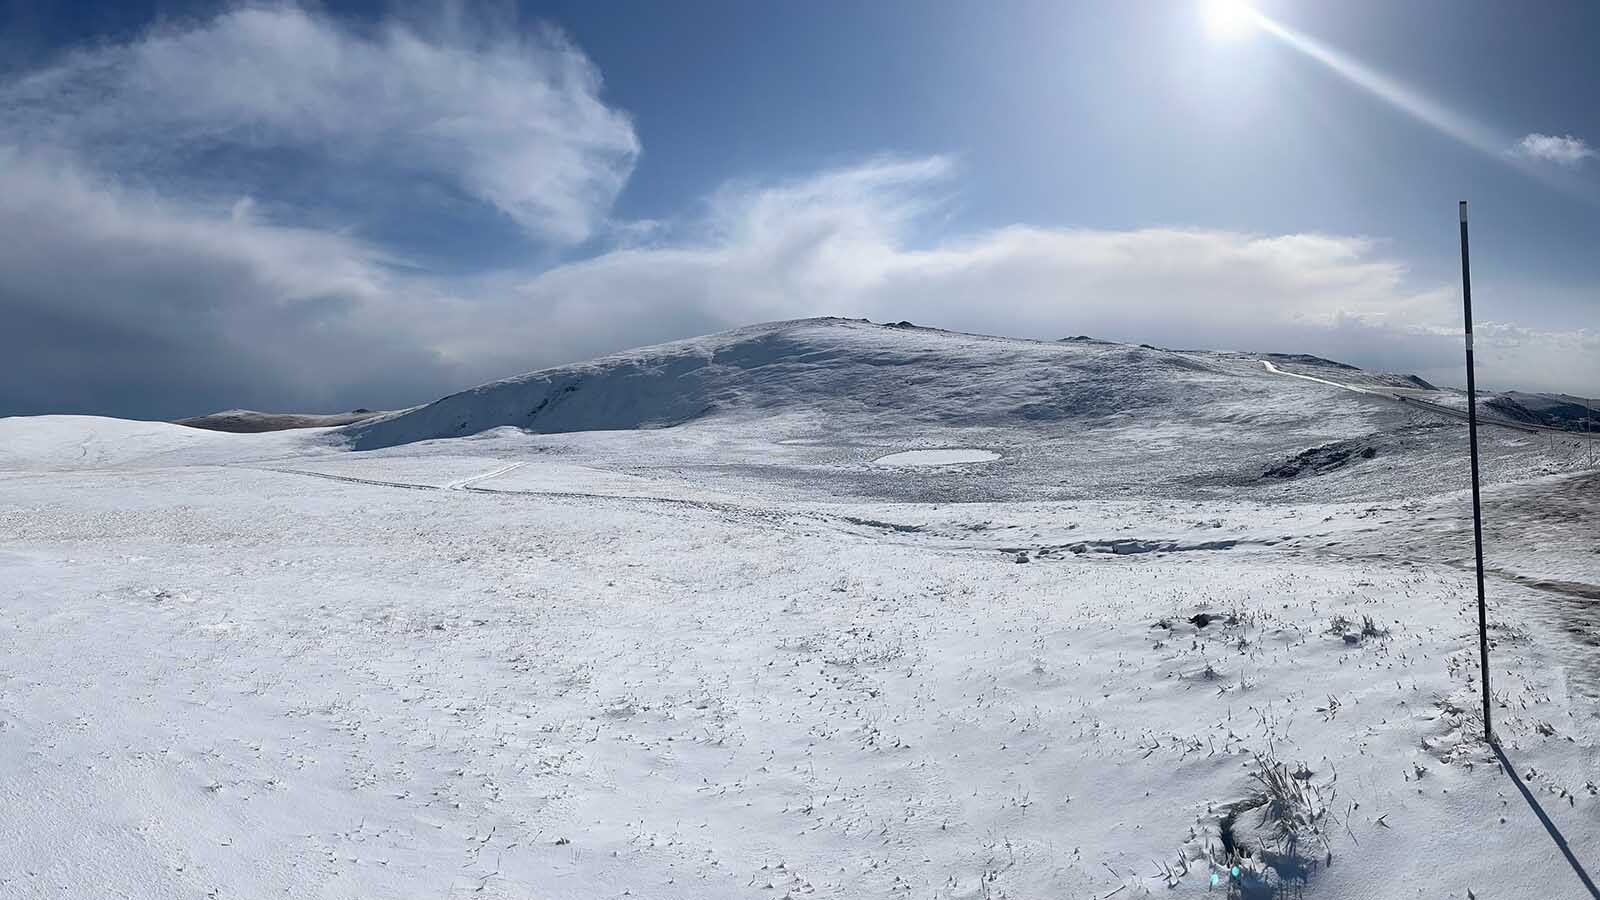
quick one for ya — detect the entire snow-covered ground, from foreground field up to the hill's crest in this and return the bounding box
[0,320,1600,898]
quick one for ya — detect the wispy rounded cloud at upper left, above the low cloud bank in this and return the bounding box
[0,5,638,243]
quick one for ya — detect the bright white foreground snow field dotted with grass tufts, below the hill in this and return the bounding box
[0,460,1597,898]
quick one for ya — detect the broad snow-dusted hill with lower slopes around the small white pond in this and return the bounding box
[341,319,1574,500]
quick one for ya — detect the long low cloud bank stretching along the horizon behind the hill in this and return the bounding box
[0,149,1600,416]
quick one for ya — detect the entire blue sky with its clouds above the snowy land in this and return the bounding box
[0,0,1600,416]
